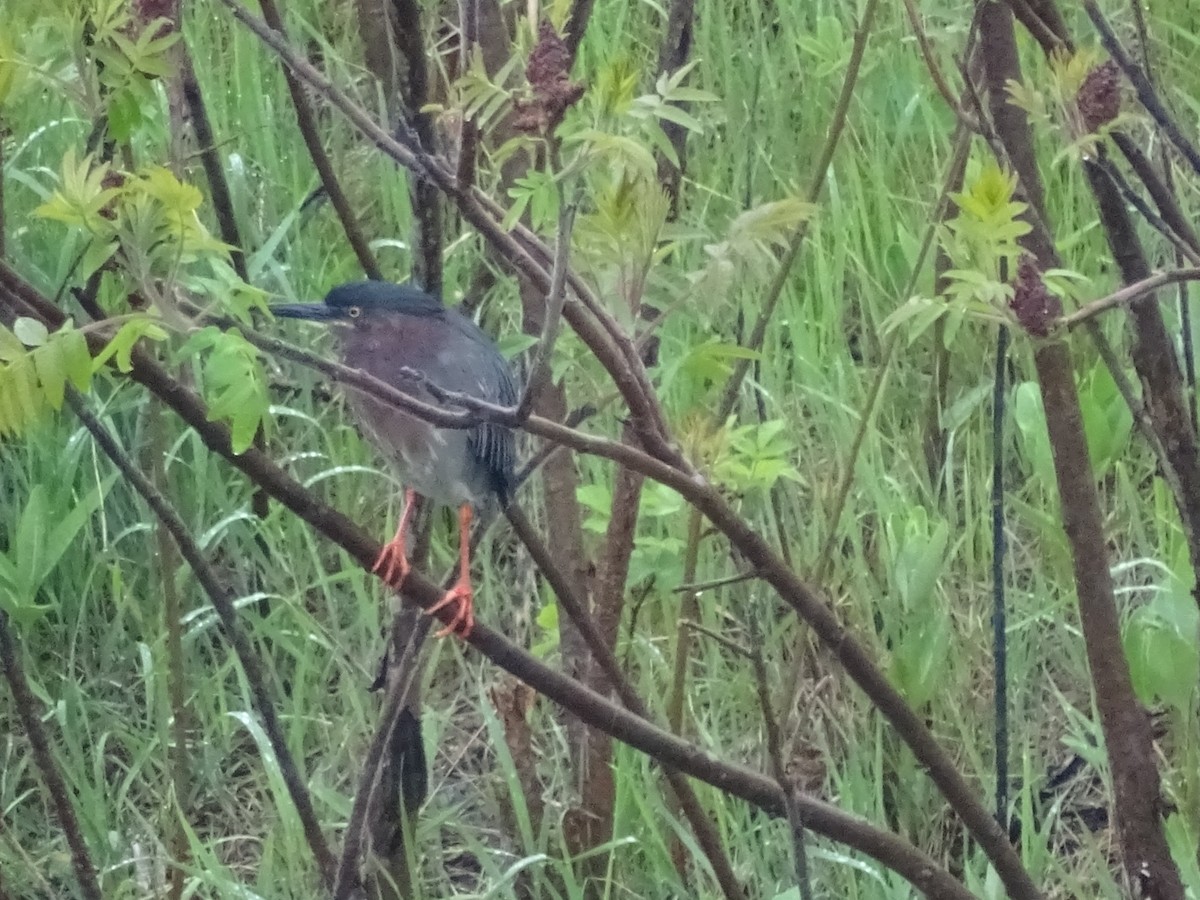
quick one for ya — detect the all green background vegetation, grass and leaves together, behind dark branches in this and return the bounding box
[0,0,1200,899]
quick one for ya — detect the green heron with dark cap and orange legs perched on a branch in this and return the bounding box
[271,281,517,637]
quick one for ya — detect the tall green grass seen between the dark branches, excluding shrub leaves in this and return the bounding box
[0,0,1200,900]
